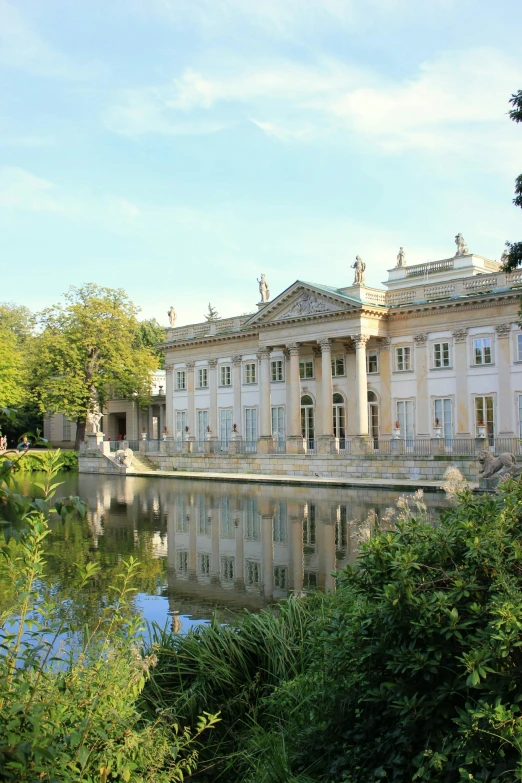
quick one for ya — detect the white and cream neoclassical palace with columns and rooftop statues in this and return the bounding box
[162,234,522,454]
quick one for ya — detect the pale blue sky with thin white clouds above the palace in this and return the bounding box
[0,0,522,326]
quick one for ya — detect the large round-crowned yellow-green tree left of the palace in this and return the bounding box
[33,283,158,448]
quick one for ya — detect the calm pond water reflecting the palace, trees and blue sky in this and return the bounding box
[7,473,447,632]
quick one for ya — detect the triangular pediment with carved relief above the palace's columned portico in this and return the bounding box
[243,280,361,326]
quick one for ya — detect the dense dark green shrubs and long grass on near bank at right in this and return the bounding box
[144,481,522,783]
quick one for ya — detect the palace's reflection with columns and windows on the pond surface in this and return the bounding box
[79,475,446,618]
